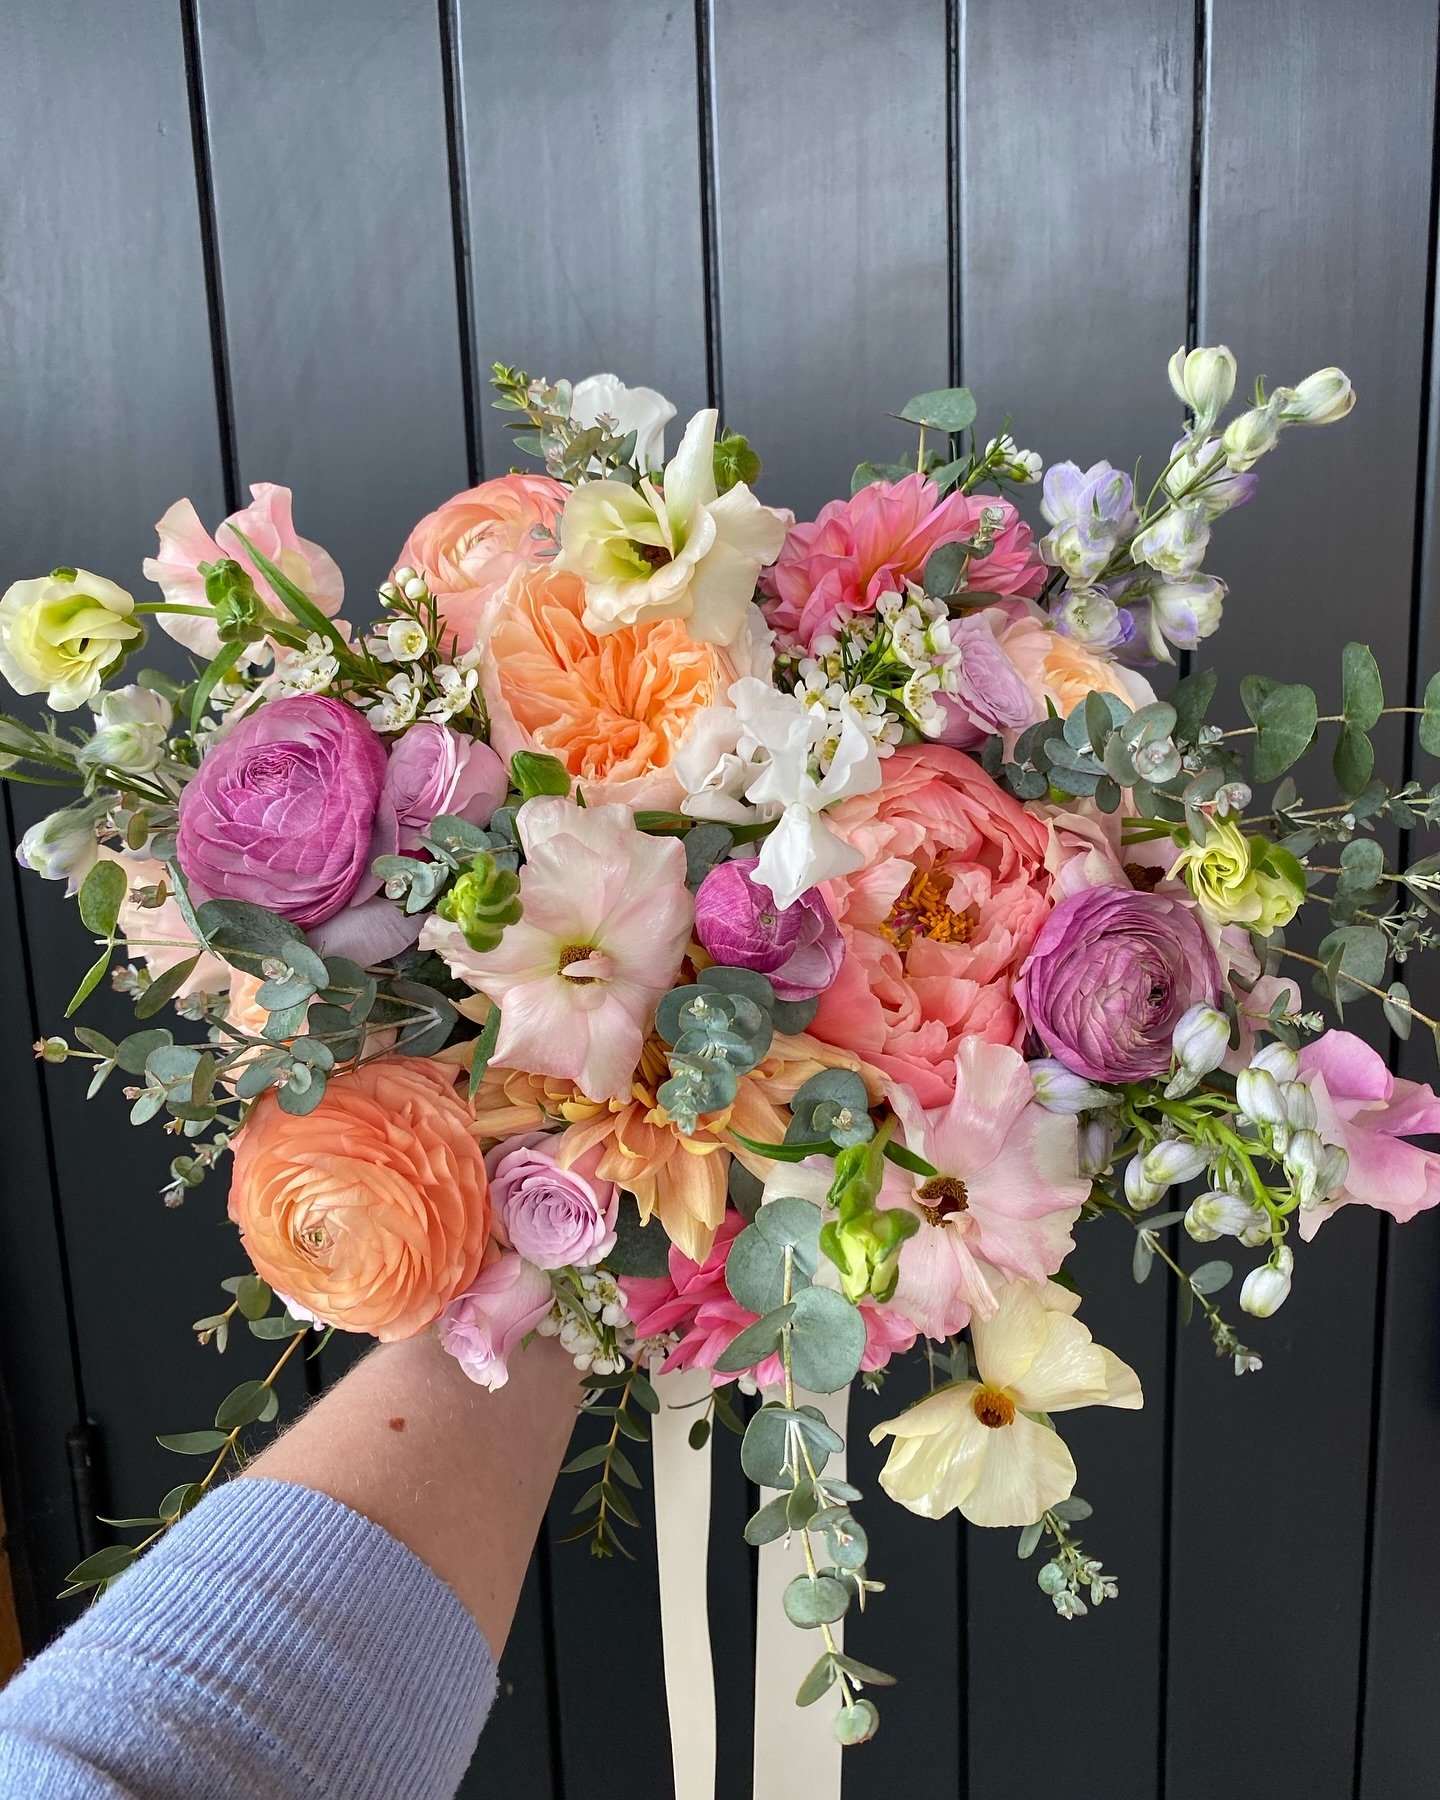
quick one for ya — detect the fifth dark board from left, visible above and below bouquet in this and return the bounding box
[959,0,1195,1800]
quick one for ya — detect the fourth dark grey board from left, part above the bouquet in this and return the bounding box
[713,0,950,518]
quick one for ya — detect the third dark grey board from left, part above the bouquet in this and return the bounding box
[457,0,706,473]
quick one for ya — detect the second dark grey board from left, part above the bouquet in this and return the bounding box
[198,0,466,590]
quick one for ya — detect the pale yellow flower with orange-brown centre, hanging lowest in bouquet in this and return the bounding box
[869,1282,1141,1525]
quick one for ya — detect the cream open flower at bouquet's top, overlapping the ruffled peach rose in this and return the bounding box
[554,409,788,644]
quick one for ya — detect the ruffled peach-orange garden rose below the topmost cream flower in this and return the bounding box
[481,567,743,810]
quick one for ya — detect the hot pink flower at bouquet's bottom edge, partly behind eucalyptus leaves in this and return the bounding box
[625,1211,916,1388]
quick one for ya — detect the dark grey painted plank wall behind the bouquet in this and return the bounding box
[0,0,1440,1800]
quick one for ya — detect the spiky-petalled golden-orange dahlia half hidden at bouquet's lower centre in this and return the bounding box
[475,1037,880,1262]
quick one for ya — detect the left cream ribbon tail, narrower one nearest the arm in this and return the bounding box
[652,1368,720,1800]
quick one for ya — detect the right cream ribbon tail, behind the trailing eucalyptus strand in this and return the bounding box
[754,1388,850,1800]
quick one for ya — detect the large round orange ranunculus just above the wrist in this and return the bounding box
[230,1057,490,1343]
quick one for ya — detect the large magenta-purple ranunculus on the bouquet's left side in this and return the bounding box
[176,693,385,927]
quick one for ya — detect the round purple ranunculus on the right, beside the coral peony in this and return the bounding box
[1015,887,1222,1082]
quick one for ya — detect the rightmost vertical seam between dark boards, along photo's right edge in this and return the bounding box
[1352,14,1440,1800]
